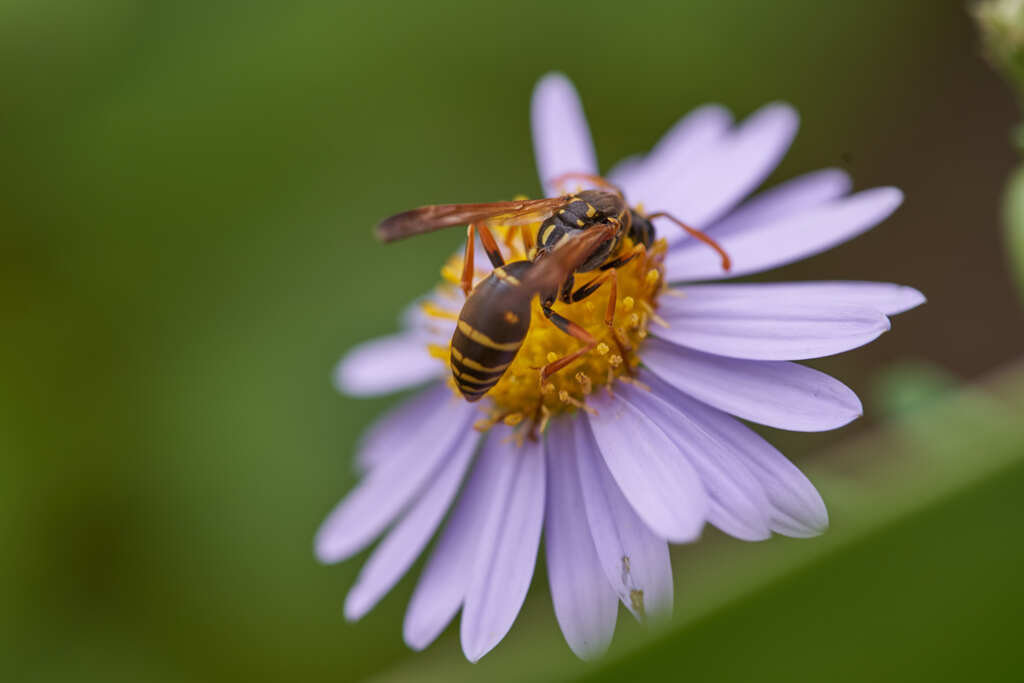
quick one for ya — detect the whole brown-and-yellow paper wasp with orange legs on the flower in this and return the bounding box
[377,173,729,401]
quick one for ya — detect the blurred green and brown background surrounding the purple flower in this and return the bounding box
[6,0,1024,682]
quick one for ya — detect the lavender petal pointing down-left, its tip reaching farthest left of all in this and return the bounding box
[314,402,475,562]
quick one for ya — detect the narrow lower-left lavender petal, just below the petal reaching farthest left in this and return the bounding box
[345,430,479,622]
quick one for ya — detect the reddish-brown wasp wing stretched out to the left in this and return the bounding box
[376,197,565,242]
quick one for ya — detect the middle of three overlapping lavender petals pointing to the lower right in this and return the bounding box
[616,386,771,541]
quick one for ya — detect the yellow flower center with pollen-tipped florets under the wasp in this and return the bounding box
[427,225,667,430]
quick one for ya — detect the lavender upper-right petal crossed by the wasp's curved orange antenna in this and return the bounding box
[665,187,903,282]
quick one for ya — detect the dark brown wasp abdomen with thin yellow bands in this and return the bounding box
[450,261,532,401]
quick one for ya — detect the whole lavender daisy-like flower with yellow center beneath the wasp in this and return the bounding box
[315,75,925,661]
